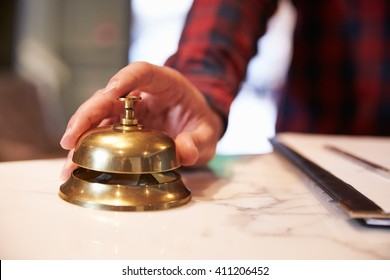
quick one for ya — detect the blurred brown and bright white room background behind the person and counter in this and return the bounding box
[0,0,295,161]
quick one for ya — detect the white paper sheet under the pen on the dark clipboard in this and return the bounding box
[277,133,390,213]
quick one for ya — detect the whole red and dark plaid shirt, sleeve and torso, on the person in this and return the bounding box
[166,0,390,135]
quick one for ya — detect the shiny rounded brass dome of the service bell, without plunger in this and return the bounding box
[73,126,180,174]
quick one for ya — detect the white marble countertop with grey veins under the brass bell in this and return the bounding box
[0,153,390,259]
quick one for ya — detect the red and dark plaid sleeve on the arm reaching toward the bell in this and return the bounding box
[165,0,277,129]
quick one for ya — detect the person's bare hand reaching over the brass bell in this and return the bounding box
[60,62,223,180]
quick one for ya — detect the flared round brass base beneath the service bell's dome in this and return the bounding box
[59,168,191,211]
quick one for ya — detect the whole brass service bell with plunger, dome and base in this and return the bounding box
[59,97,191,211]
